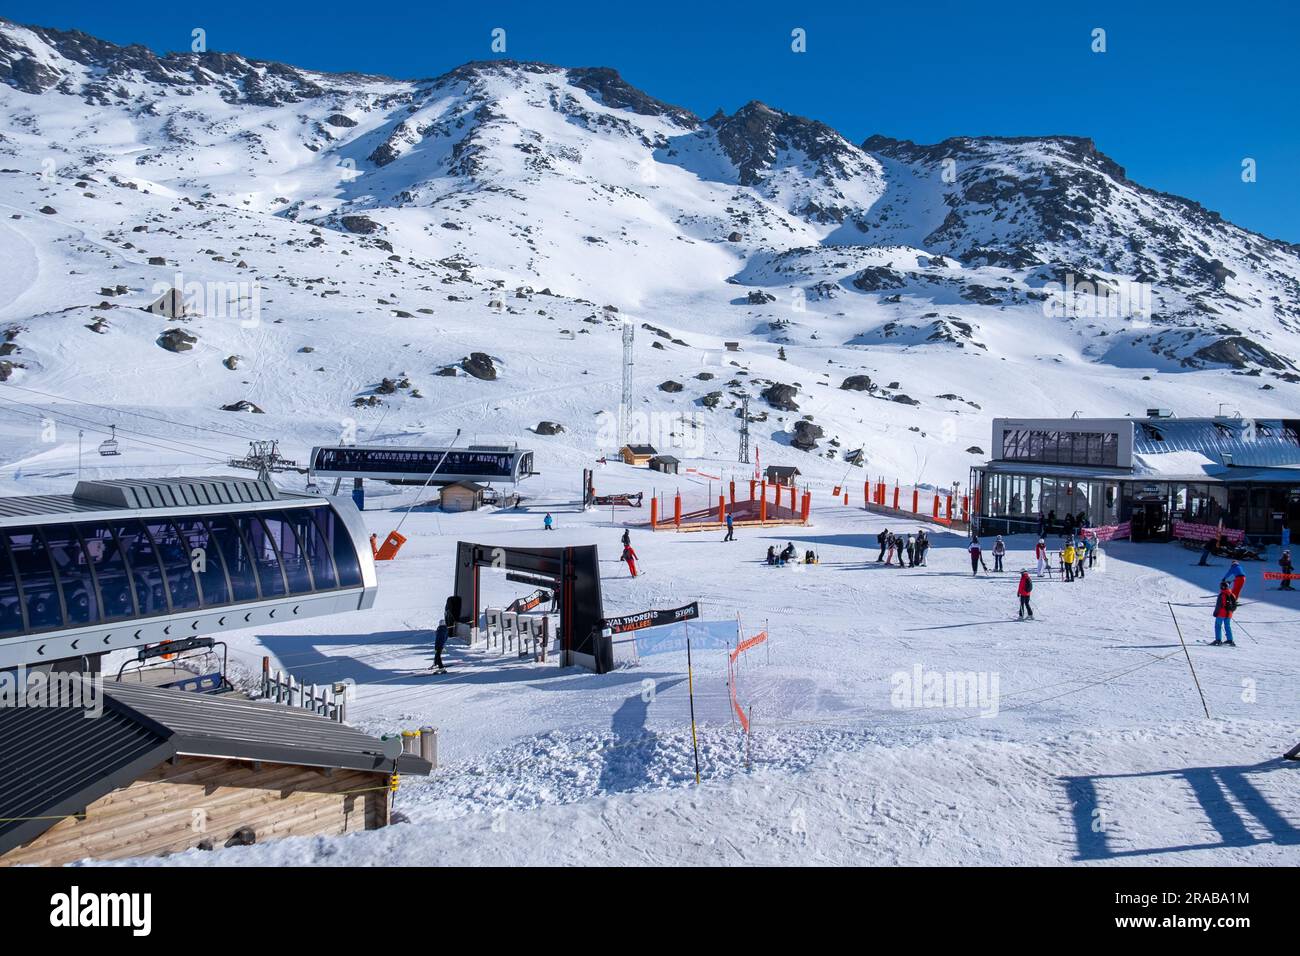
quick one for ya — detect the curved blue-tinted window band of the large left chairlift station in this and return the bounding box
[0,507,361,637]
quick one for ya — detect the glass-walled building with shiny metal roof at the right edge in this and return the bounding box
[970,408,1300,544]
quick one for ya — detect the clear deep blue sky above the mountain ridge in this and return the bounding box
[10,0,1300,242]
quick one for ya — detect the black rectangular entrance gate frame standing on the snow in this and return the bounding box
[456,541,614,674]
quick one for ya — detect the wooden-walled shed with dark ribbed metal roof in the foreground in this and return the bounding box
[0,683,433,866]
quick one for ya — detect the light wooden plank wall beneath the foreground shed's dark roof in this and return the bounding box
[0,757,389,866]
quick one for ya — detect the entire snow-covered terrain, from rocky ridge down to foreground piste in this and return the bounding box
[0,21,1300,862]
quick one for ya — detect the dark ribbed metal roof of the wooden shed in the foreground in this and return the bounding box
[0,683,433,853]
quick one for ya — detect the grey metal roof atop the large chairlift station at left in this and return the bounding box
[0,477,324,524]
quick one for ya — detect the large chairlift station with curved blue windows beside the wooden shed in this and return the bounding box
[0,477,376,671]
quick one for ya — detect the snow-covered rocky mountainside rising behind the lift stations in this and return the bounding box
[0,13,1300,489]
